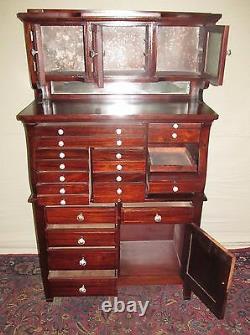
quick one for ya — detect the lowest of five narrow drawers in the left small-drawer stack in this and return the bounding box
[37,194,89,206]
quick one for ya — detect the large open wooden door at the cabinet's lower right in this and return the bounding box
[182,224,235,319]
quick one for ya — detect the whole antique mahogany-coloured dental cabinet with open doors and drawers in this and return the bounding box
[17,9,235,318]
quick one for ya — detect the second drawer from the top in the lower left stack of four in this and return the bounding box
[46,228,116,247]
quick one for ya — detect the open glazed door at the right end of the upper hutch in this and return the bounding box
[204,26,229,85]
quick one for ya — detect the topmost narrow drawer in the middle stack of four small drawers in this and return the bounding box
[92,149,146,161]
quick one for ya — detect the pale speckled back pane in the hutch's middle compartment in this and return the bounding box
[103,27,146,71]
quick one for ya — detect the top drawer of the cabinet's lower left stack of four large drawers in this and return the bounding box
[45,207,116,224]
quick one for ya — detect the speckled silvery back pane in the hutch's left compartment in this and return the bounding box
[41,26,85,72]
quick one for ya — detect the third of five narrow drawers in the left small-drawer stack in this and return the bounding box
[36,171,89,185]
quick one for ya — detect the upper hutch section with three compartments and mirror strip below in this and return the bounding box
[17,9,228,99]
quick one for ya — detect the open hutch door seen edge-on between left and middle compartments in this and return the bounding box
[90,24,104,87]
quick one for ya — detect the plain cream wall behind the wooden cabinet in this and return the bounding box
[0,0,250,253]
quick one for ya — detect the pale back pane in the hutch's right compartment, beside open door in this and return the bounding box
[157,27,200,72]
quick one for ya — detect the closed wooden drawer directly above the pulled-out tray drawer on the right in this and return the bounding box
[148,123,200,144]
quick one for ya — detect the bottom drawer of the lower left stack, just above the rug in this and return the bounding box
[48,270,117,297]
